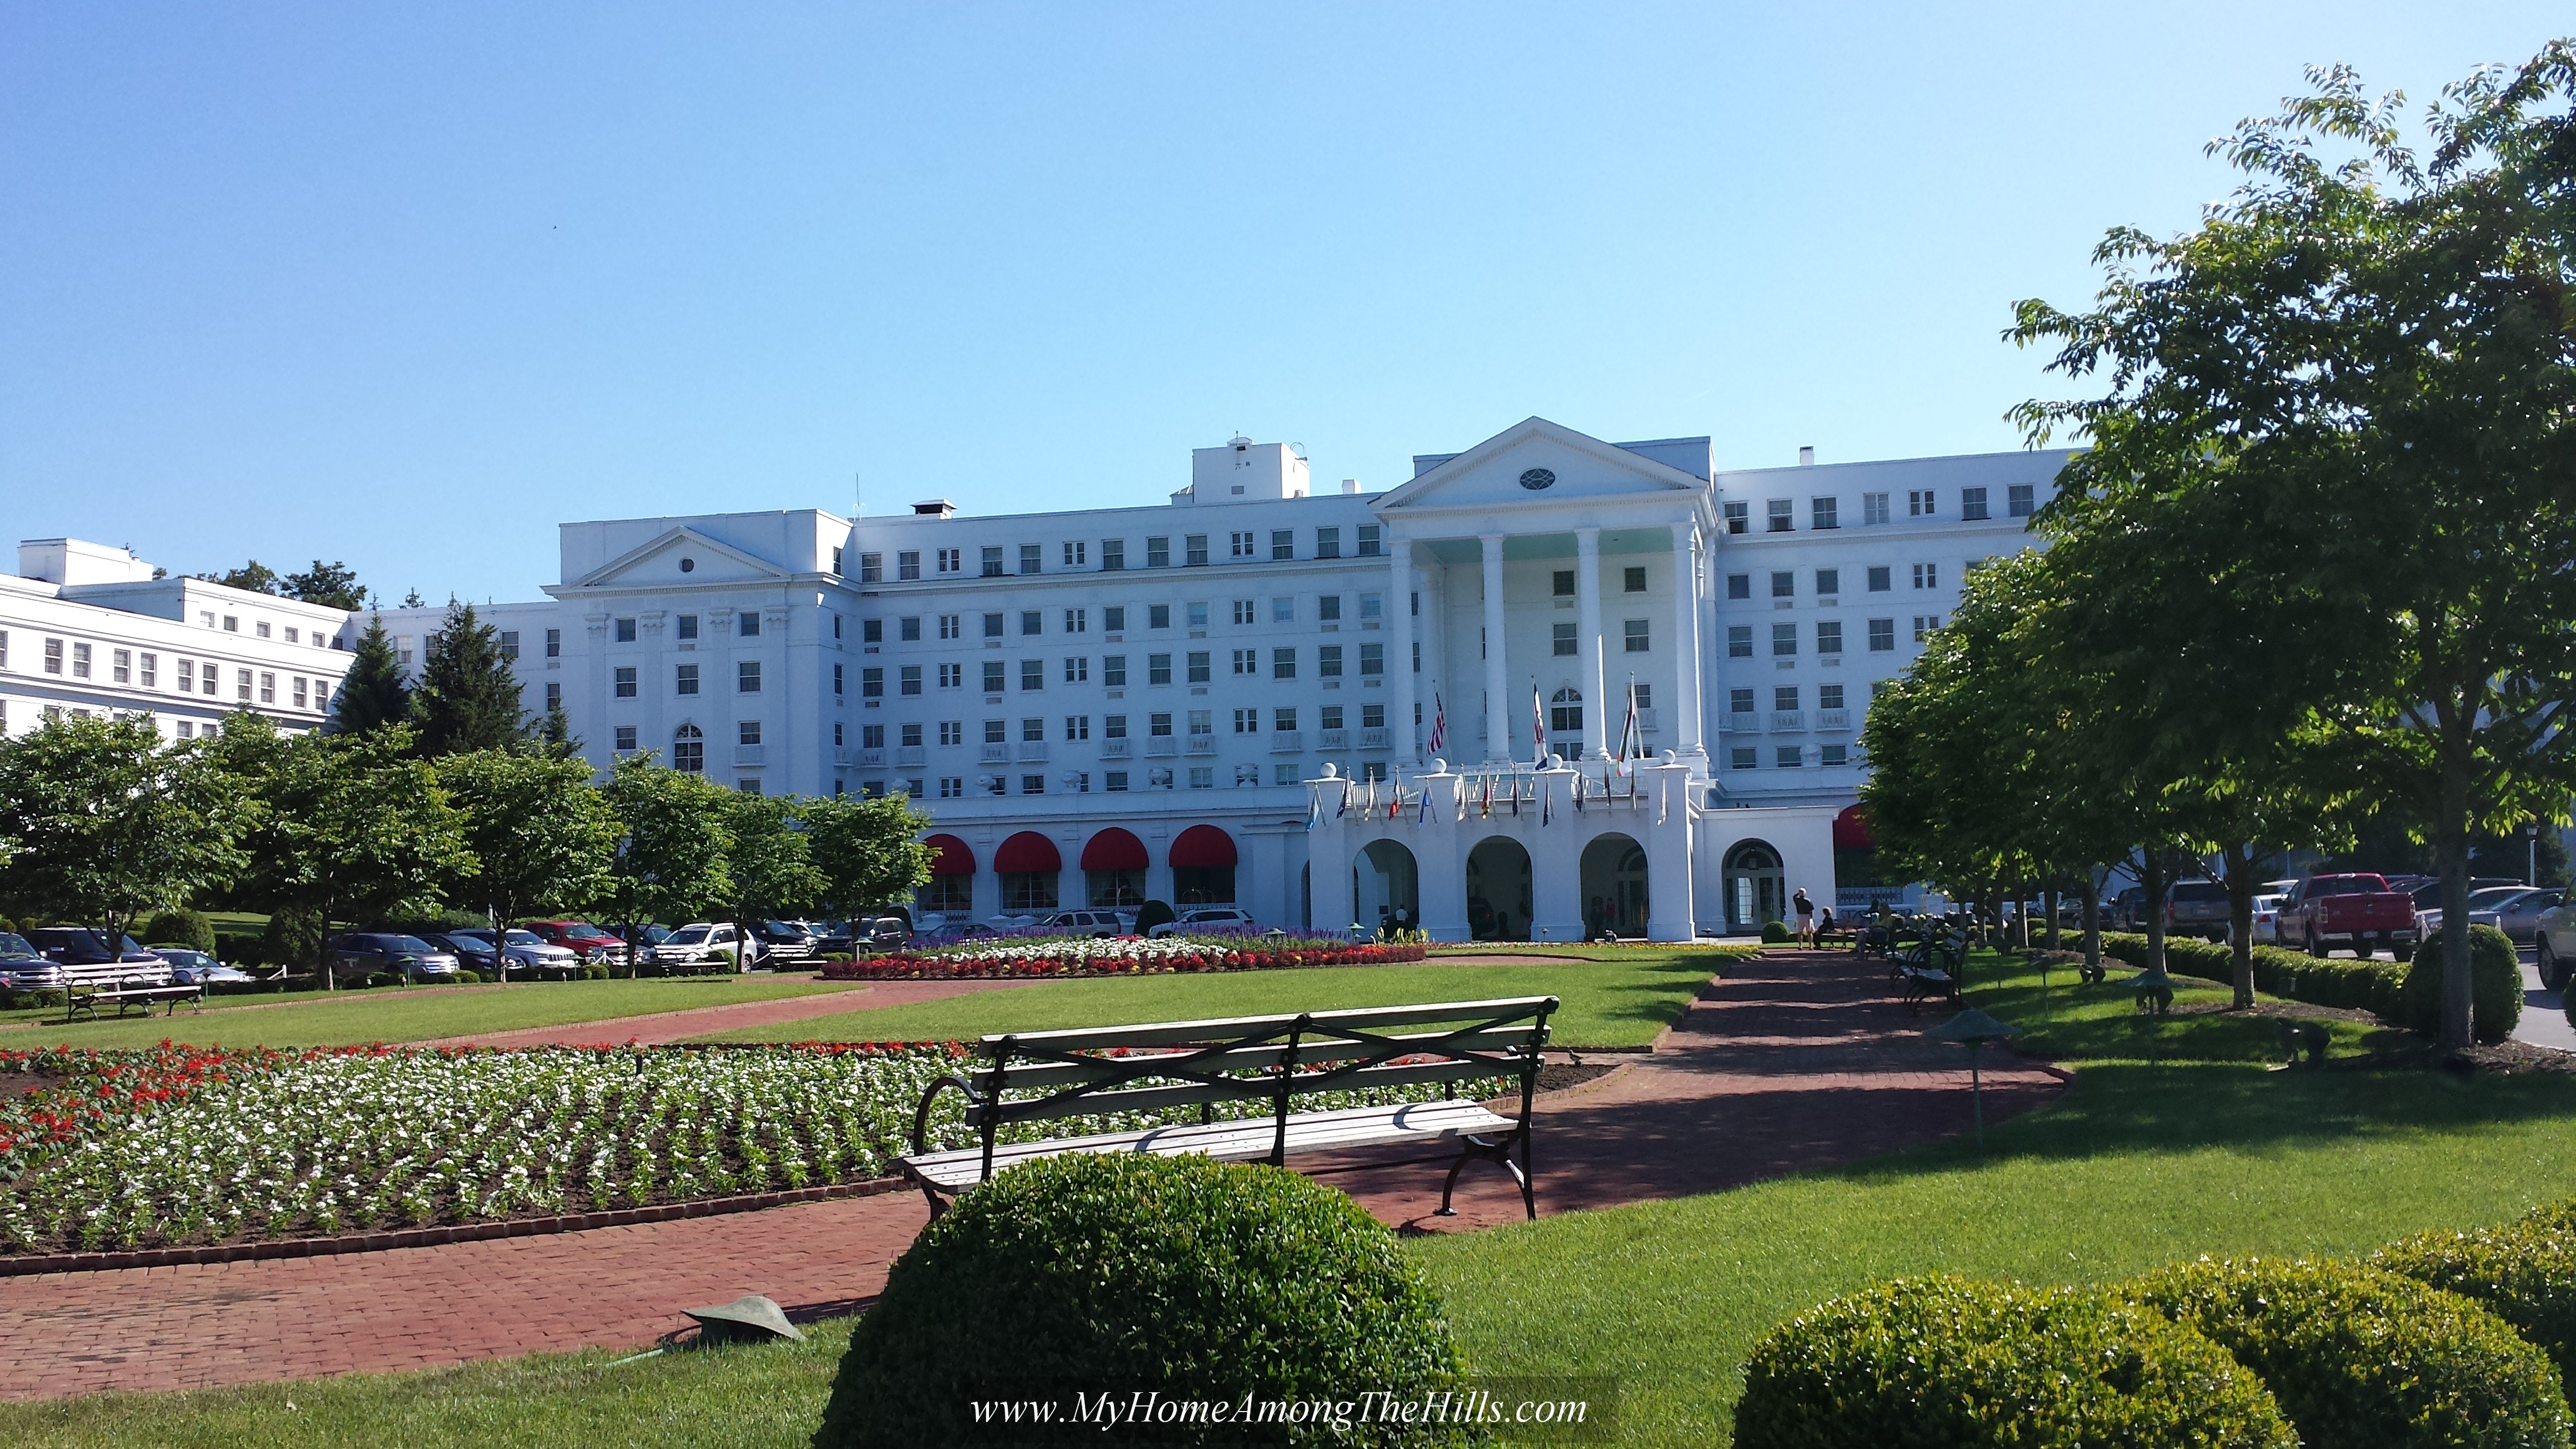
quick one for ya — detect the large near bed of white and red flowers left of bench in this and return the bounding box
[0,1042,1499,1253]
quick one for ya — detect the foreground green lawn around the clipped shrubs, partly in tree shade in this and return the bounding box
[20,962,2576,1447]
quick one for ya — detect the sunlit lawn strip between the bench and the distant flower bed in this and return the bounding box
[706,952,1726,1046]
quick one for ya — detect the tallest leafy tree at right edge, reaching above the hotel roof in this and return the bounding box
[2014,41,2576,1046]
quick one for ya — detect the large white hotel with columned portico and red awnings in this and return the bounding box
[368,417,2066,939]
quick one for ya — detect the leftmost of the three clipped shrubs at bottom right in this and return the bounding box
[1736,1276,2298,1449]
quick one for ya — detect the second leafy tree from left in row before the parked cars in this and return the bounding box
[214,714,477,990]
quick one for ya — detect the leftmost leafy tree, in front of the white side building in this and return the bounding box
[0,714,255,946]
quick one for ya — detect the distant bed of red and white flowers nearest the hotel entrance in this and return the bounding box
[822,936,1425,980]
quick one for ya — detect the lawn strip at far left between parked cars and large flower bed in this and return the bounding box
[0,975,850,1052]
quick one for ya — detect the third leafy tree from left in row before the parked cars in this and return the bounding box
[436,750,618,980]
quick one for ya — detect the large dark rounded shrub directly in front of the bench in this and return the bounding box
[814,1153,1466,1449]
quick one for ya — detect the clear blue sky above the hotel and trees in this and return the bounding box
[0,0,2576,601]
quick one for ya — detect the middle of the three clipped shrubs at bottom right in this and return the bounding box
[2128,1258,2569,1449]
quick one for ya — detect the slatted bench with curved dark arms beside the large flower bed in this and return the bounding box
[897,995,1556,1219]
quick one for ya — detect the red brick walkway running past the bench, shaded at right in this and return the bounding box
[0,954,2058,1397]
